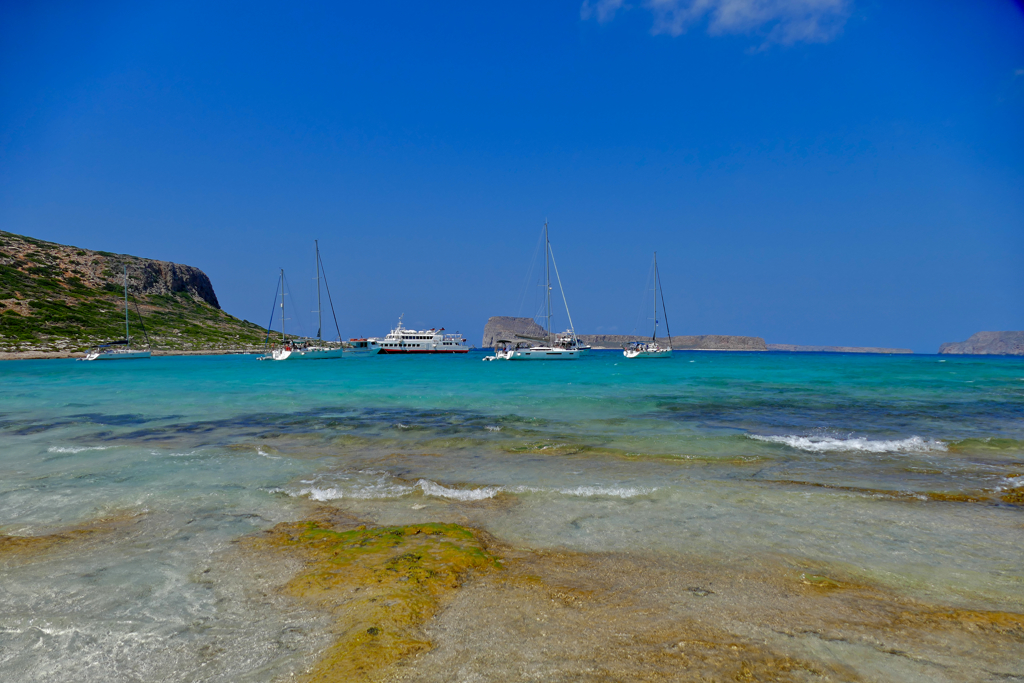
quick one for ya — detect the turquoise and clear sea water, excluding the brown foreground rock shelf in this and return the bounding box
[0,351,1024,681]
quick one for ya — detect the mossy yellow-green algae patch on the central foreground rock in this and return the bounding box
[253,521,501,683]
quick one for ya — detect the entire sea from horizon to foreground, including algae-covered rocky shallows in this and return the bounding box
[0,351,1024,681]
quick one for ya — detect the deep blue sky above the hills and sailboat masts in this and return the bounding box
[0,0,1024,352]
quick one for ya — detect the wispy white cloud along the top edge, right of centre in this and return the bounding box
[580,0,852,46]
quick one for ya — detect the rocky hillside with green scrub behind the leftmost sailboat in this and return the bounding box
[0,231,265,351]
